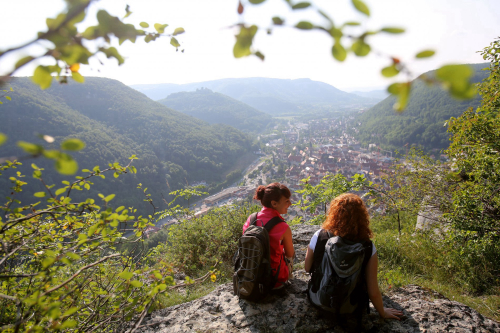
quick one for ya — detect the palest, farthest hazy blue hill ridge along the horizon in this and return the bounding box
[131,78,376,115]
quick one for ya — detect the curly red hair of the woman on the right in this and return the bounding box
[321,193,373,242]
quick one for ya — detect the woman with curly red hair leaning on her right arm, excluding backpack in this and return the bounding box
[304,193,403,320]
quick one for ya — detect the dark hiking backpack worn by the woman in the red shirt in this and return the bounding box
[233,213,283,301]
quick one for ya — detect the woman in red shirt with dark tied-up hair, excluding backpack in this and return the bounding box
[243,183,295,289]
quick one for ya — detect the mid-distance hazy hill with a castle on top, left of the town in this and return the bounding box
[158,88,274,133]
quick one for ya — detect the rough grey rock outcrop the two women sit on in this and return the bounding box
[139,226,500,333]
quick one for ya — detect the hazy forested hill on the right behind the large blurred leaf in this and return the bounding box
[355,63,488,149]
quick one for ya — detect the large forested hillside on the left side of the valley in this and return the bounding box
[0,78,251,213]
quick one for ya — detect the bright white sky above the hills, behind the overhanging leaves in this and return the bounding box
[0,0,500,91]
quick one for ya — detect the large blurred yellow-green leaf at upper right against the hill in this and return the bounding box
[436,65,476,99]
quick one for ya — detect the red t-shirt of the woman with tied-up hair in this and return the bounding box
[243,207,290,287]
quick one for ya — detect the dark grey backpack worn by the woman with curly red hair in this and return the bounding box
[308,230,373,316]
